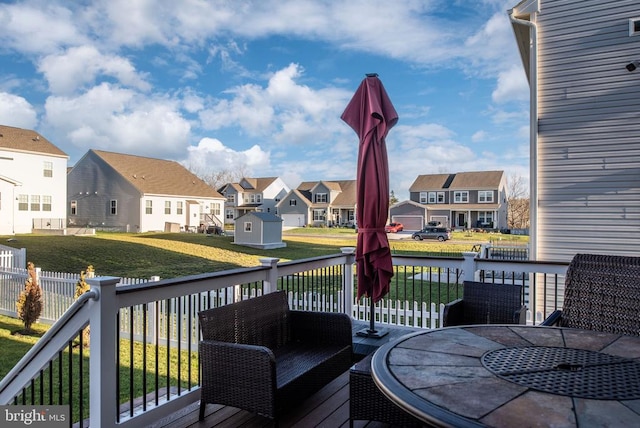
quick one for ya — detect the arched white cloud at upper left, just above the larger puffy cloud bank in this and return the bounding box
[38,46,150,95]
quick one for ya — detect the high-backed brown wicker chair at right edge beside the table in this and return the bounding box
[542,254,640,336]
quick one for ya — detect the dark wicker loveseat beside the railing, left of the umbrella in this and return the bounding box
[198,291,353,424]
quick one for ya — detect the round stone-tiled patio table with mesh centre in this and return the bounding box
[371,325,640,427]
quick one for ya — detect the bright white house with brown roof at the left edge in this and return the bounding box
[0,125,69,235]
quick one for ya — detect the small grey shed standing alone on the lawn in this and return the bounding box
[233,212,287,250]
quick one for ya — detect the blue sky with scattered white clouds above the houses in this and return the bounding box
[0,0,529,199]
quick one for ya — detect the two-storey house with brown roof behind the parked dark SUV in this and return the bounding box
[404,171,507,229]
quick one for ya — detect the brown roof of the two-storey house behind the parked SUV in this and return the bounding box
[409,171,504,192]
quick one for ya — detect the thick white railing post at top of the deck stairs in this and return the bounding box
[87,276,120,428]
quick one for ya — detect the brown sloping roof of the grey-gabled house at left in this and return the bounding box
[89,150,222,199]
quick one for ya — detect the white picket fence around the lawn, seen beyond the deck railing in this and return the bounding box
[0,268,444,350]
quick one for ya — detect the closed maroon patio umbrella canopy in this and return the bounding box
[341,74,398,302]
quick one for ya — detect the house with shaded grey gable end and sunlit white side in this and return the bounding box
[67,150,224,232]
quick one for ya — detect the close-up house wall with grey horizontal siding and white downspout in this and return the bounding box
[509,0,640,261]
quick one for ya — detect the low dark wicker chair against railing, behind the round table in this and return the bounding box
[442,281,527,327]
